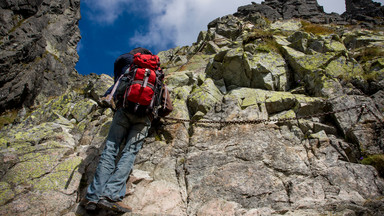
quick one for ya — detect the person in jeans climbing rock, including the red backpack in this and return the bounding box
[83,48,173,213]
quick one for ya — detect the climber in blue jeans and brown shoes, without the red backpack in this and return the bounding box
[82,48,173,213]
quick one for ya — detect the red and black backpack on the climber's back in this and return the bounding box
[112,53,164,115]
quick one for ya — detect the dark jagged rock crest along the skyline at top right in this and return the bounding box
[235,0,384,28]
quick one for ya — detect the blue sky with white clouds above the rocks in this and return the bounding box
[76,0,384,76]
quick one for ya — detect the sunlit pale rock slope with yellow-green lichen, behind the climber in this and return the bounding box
[0,1,384,216]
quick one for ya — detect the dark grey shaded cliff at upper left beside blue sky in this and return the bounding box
[0,0,80,112]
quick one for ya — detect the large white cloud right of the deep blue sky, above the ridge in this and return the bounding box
[131,0,261,50]
